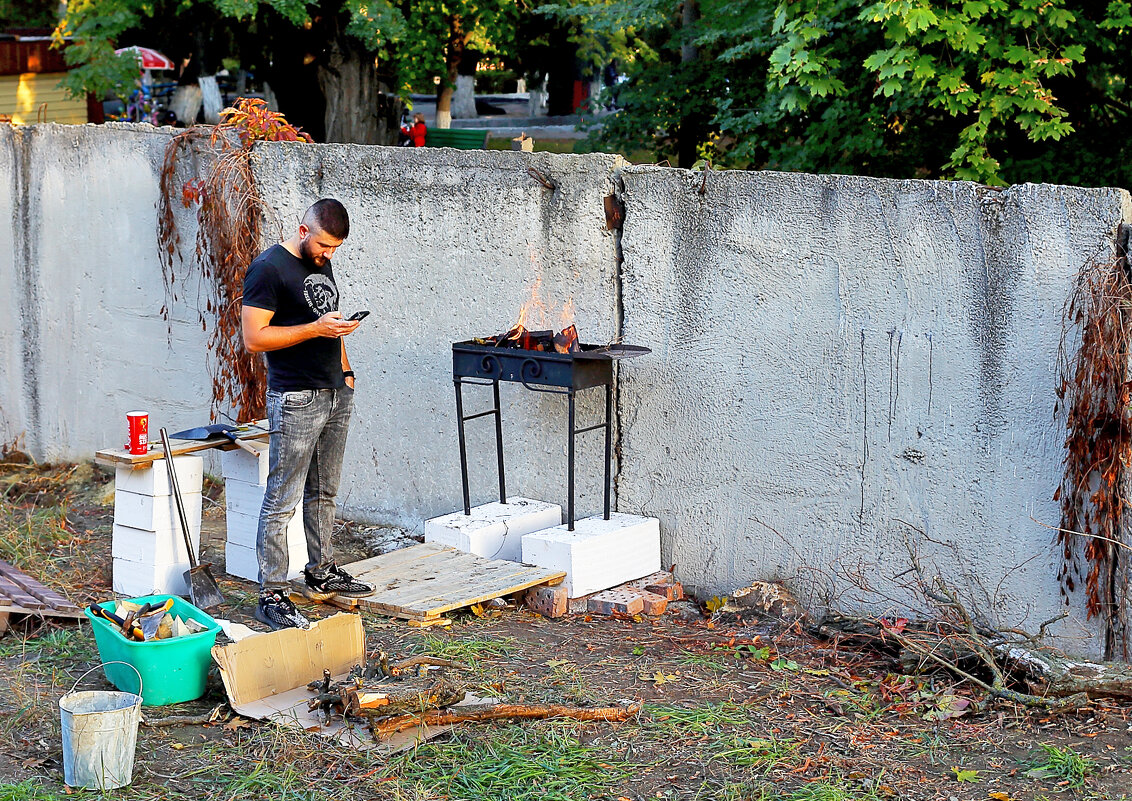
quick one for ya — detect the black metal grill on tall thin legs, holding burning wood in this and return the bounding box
[452,339,651,531]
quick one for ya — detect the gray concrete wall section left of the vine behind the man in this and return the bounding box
[0,126,208,459]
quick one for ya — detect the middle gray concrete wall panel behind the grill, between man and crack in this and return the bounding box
[249,144,620,529]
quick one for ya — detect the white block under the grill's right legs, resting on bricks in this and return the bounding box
[523,511,660,598]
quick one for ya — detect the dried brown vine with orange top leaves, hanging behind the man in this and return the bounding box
[157,97,310,421]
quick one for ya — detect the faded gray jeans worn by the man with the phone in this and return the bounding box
[256,387,353,589]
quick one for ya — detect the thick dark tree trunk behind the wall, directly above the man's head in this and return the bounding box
[318,35,403,145]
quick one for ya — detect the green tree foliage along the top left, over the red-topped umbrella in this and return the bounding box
[49,0,518,137]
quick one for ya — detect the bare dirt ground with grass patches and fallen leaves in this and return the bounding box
[0,454,1132,801]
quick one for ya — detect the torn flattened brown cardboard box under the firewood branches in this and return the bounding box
[212,612,482,753]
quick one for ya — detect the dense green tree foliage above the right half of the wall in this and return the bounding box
[549,0,1132,184]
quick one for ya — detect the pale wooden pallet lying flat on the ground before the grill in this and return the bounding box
[332,542,566,622]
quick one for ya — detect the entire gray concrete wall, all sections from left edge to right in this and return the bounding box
[0,126,1132,649]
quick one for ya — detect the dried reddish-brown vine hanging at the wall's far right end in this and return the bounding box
[1054,226,1132,658]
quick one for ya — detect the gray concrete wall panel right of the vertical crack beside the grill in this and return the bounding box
[618,167,1129,635]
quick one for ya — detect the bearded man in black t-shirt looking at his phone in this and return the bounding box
[241,198,374,629]
